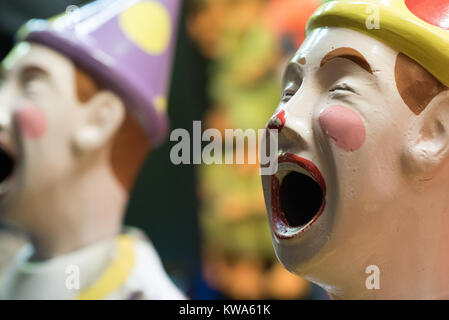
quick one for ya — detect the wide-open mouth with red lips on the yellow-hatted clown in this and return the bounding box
[271,154,326,239]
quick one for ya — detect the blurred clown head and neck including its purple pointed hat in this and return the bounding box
[0,0,180,258]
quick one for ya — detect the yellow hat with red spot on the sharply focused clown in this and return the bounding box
[306,0,449,86]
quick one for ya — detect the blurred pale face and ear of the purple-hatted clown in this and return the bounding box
[0,43,124,229]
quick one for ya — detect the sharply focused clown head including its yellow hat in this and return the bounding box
[262,0,449,298]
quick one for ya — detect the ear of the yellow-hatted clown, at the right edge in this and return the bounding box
[402,90,449,182]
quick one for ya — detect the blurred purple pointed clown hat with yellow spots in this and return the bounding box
[18,0,182,145]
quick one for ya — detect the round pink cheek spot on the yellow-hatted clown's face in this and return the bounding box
[319,105,366,151]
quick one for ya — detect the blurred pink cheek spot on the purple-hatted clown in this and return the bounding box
[17,106,47,140]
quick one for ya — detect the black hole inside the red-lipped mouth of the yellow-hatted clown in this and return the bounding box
[279,171,323,227]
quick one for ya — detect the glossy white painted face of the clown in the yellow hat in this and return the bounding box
[262,28,449,297]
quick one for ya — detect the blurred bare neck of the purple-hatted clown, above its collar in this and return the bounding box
[27,154,128,261]
